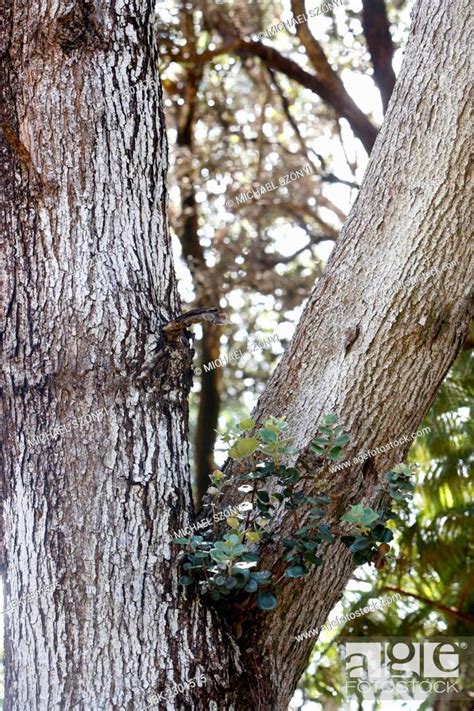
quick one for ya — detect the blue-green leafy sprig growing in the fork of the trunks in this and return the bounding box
[175,414,413,610]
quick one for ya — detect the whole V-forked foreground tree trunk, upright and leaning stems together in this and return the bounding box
[0,0,472,711]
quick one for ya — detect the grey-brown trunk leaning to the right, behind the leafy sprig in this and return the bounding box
[202,1,474,710]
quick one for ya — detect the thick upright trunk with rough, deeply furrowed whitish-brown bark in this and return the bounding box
[0,0,233,711]
